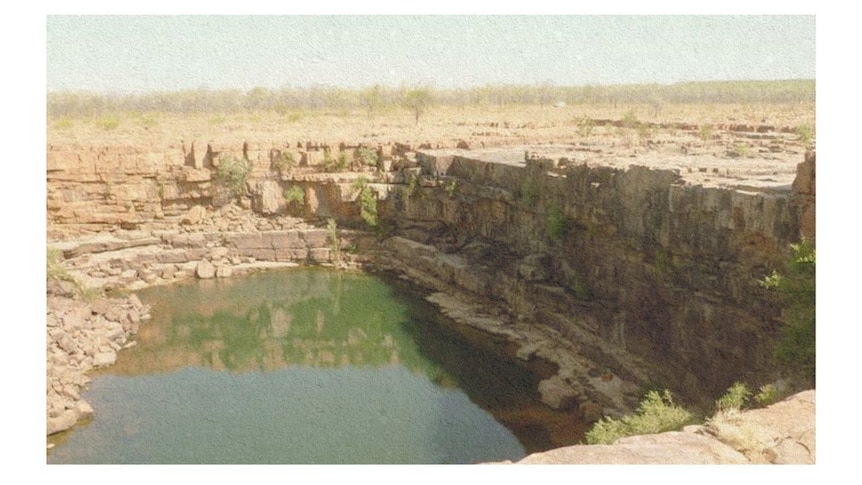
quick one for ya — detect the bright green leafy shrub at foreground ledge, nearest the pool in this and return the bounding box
[585,390,695,444]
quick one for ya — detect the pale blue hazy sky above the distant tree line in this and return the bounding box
[46,15,815,92]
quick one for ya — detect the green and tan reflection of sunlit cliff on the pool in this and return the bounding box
[107,269,446,374]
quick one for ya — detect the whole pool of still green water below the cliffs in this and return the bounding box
[47,268,588,464]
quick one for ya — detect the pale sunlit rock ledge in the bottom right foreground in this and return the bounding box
[502,390,816,465]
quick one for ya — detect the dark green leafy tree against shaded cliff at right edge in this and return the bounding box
[762,241,816,380]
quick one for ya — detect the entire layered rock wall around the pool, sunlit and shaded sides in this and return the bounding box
[47,130,815,420]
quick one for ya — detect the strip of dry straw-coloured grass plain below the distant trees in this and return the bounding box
[47,103,815,151]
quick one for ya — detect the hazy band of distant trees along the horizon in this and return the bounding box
[47,80,816,119]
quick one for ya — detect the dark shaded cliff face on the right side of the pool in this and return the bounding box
[389,147,813,404]
